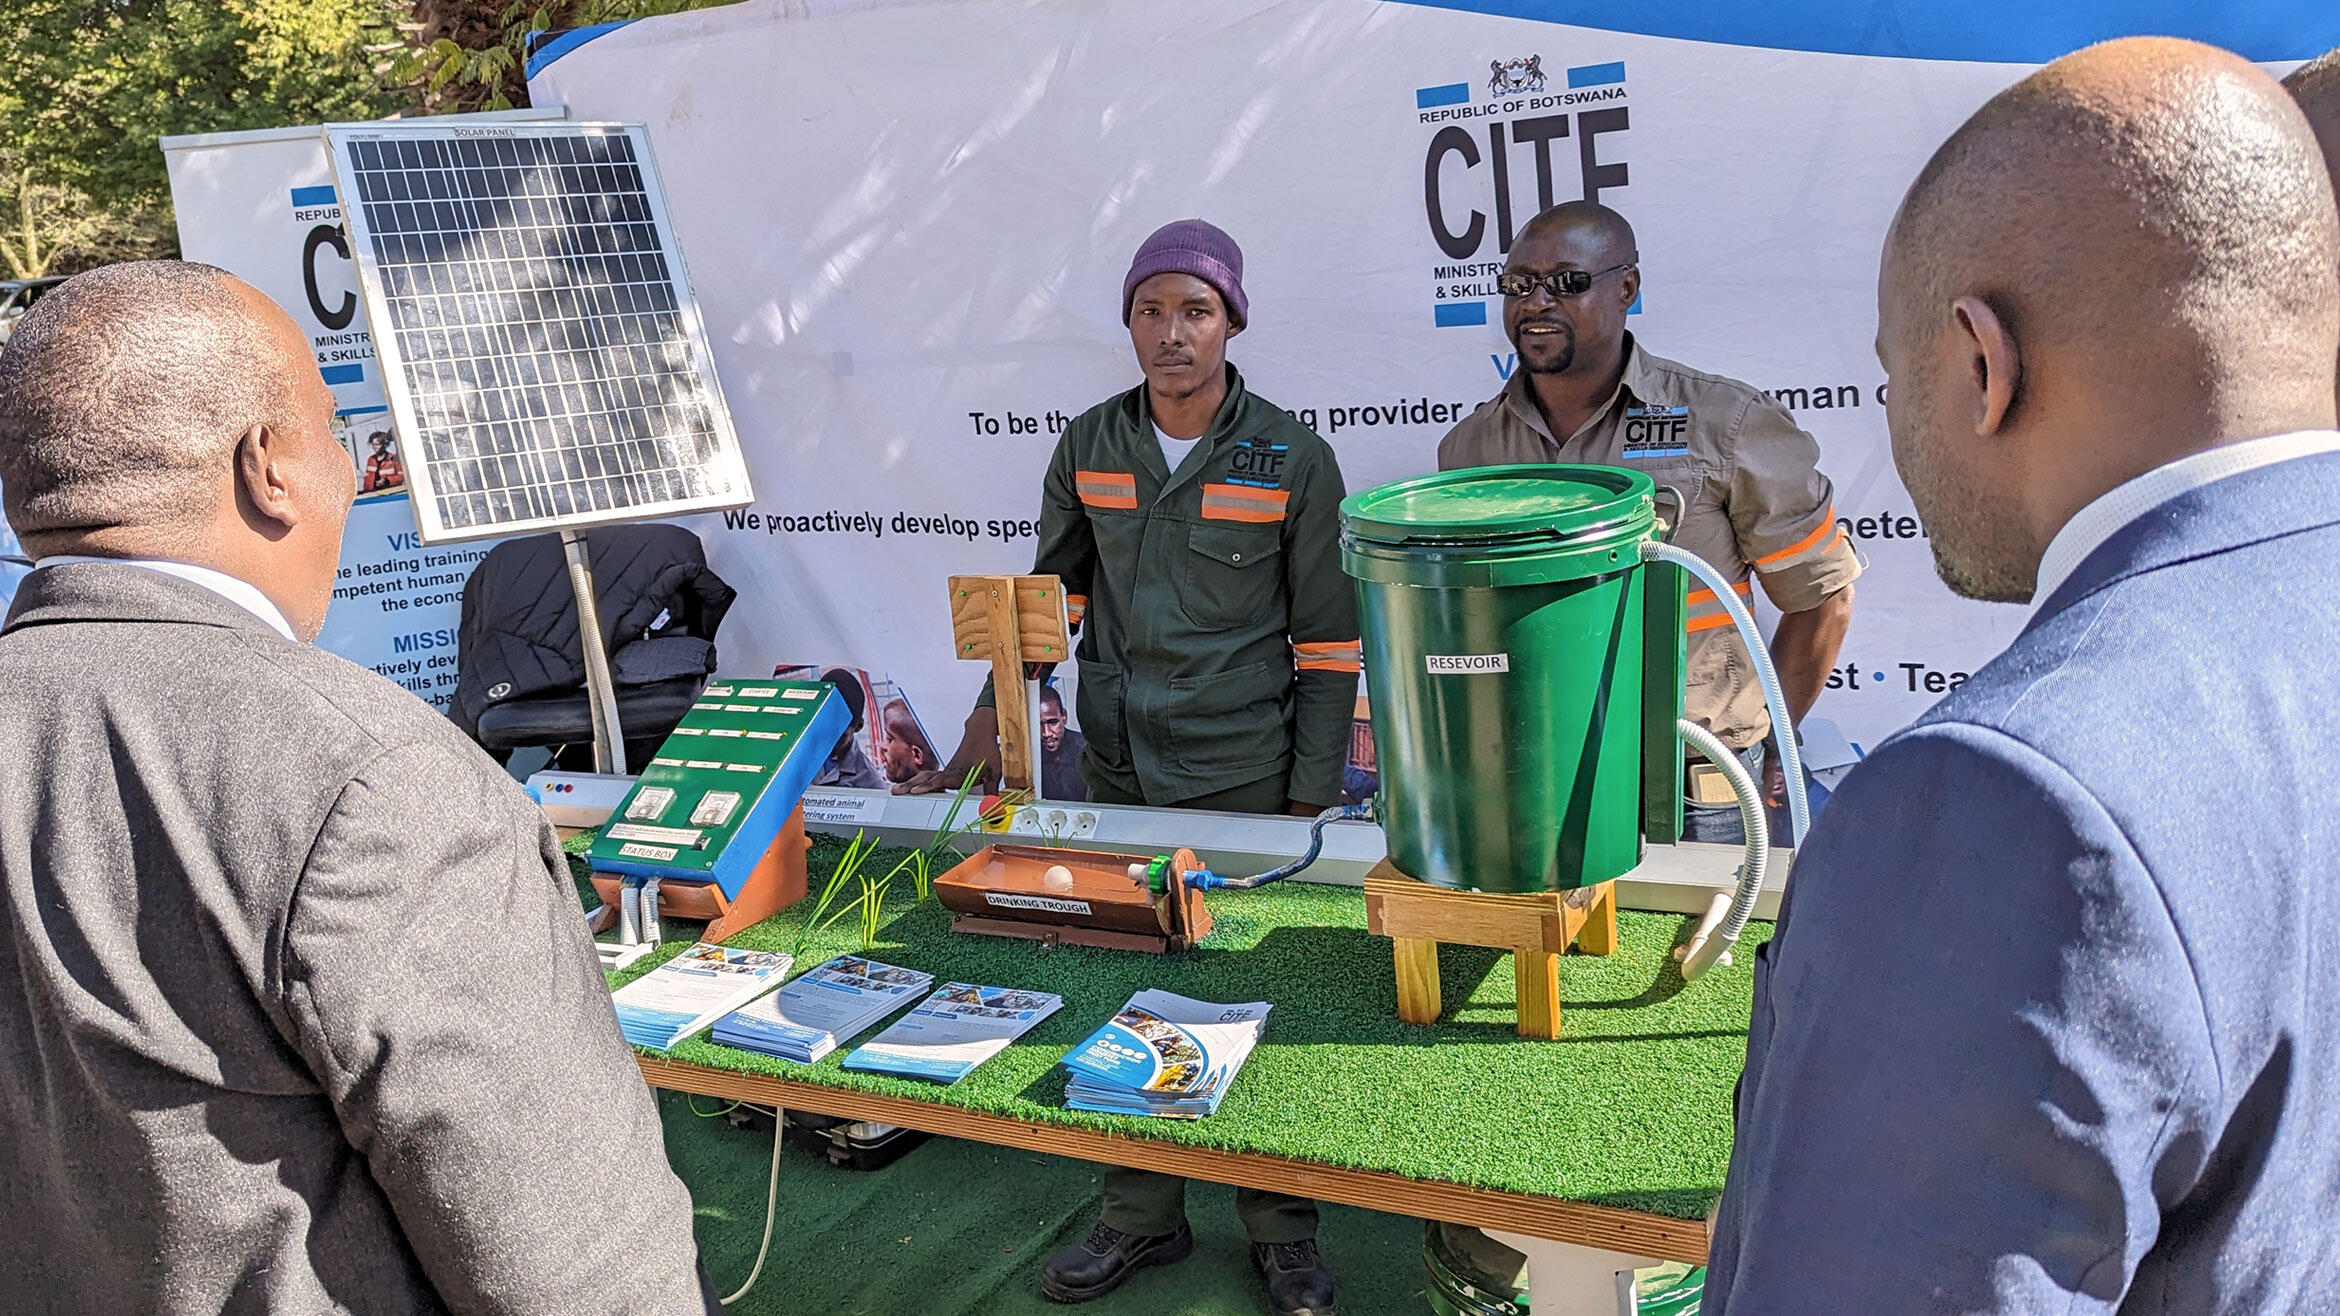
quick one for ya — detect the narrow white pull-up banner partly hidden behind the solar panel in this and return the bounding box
[161,110,559,707]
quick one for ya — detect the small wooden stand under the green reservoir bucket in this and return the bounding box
[1364,859,1617,1040]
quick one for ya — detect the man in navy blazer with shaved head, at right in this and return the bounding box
[1706,40,2340,1316]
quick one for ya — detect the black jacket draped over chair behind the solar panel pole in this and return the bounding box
[449,525,737,754]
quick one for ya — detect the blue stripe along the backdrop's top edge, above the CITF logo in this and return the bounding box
[1375,0,2340,62]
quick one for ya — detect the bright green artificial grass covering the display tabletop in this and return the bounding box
[594,836,1771,1220]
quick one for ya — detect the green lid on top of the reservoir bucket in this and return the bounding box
[1341,461,1657,583]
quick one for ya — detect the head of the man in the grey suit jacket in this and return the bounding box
[0,260,353,635]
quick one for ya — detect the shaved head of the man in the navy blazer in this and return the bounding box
[1879,37,2340,599]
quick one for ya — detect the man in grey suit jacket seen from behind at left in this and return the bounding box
[0,262,716,1316]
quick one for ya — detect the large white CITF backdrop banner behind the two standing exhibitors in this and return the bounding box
[498,0,2305,752]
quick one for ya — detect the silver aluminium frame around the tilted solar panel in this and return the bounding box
[323,122,756,543]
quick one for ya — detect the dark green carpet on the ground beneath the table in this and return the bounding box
[658,1091,1430,1316]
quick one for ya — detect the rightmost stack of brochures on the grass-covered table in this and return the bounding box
[1065,991,1268,1119]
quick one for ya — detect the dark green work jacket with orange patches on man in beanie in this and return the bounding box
[983,365,1360,806]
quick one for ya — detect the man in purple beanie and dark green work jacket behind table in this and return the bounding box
[894,220,1360,1316]
